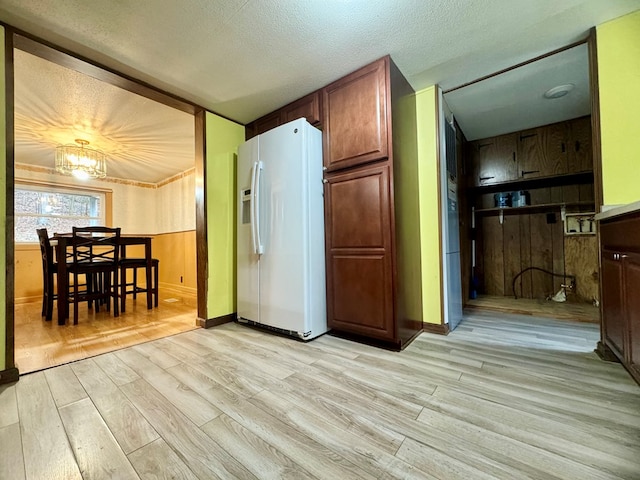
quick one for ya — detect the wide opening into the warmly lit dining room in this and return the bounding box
[13,35,199,373]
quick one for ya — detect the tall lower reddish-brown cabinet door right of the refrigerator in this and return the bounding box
[325,164,395,340]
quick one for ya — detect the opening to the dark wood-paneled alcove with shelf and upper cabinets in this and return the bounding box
[444,42,599,323]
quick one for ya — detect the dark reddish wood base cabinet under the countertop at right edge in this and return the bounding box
[598,208,640,383]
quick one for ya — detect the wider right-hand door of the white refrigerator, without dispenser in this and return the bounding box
[259,120,308,332]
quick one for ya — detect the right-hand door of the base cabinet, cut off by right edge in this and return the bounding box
[623,253,640,378]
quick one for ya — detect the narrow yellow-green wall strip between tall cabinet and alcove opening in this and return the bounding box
[416,86,442,323]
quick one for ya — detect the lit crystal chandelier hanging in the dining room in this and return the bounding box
[56,138,107,179]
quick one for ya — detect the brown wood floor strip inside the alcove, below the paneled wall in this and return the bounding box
[467,295,600,323]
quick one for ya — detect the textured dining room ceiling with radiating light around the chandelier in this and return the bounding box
[14,50,195,183]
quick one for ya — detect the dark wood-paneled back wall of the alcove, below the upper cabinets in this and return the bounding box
[476,185,599,301]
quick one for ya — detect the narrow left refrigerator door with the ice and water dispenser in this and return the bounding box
[237,137,260,322]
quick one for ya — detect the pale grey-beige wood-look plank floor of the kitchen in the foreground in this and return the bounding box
[0,313,640,480]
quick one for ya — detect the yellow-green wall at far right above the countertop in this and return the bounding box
[596,10,640,205]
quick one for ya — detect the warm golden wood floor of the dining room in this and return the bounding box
[15,292,197,373]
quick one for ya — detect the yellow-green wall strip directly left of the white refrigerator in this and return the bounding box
[205,112,244,318]
